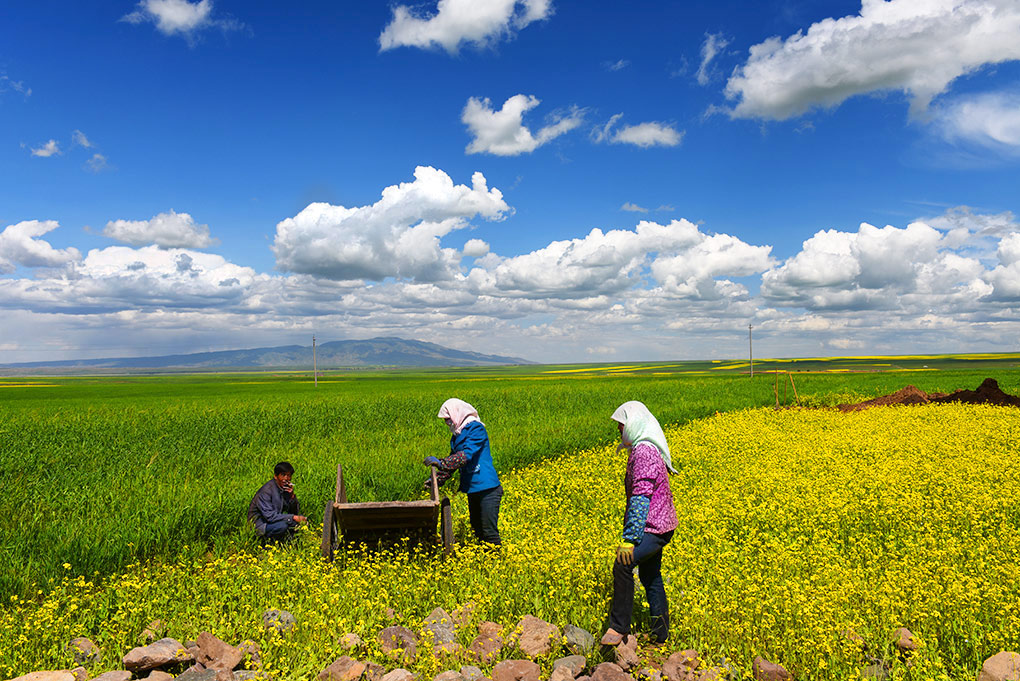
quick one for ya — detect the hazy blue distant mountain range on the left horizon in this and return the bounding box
[0,337,533,369]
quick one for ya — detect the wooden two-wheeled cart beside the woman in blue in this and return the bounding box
[322,465,453,562]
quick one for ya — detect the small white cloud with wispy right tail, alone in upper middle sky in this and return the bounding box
[460,95,583,156]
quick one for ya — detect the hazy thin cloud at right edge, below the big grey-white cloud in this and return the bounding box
[936,92,1020,154]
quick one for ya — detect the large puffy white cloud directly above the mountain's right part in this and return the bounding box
[272,166,510,281]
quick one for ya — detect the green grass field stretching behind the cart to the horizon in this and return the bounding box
[0,363,1020,600]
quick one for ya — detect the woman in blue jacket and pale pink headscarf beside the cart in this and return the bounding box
[425,399,503,545]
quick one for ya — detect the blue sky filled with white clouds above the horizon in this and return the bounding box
[0,0,1020,362]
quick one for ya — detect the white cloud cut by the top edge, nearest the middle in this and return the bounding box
[379,0,553,54]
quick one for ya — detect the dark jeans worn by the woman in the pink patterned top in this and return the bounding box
[609,530,673,642]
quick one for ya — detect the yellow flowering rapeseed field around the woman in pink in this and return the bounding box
[0,405,1020,679]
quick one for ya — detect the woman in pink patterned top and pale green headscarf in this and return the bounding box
[602,402,676,645]
